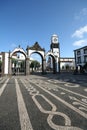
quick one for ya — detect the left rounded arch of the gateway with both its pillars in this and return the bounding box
[8,46,29,75]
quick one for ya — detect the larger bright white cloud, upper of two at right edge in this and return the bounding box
[72,25,87,38]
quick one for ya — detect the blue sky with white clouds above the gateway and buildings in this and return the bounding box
[0,0,87,60]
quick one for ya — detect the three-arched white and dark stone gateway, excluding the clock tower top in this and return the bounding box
[8,39,60,75]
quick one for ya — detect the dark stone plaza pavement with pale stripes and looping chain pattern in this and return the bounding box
[0,74,87,130]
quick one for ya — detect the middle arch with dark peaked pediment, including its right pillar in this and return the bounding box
[27,42,46,74]
